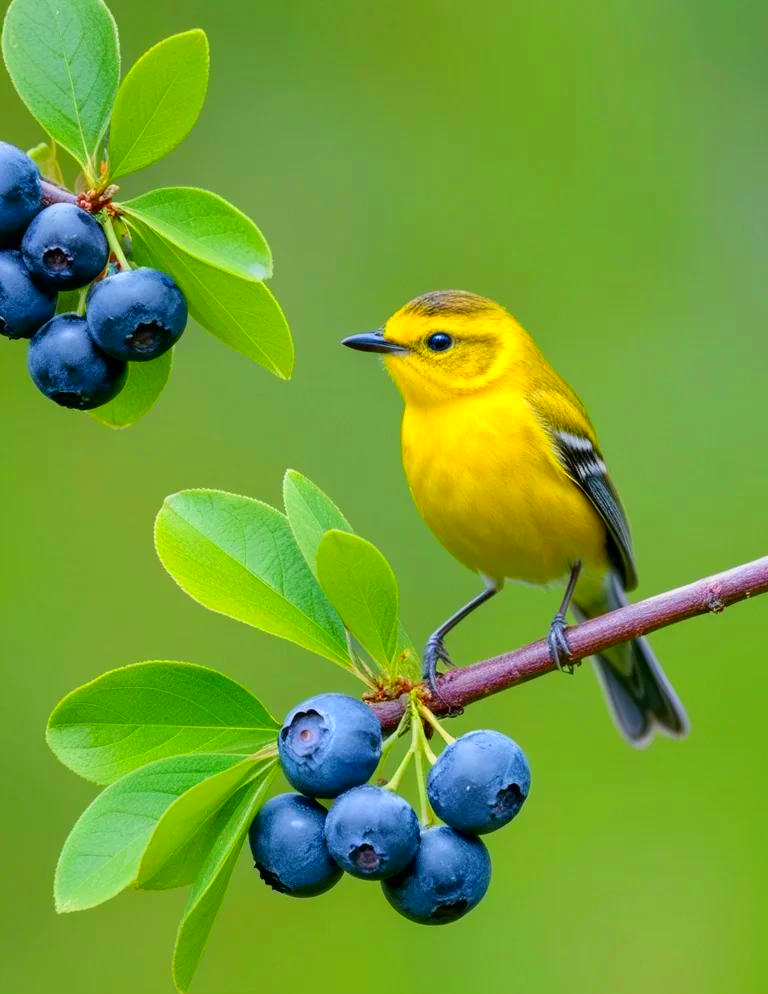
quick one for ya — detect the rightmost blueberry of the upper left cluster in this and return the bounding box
[88,268,187,360]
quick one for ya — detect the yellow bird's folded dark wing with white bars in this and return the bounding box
[530,384,637,590]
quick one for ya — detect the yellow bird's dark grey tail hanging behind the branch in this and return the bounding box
[574,572,688,747]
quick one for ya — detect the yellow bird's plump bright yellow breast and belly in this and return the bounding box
[402,388,607,584]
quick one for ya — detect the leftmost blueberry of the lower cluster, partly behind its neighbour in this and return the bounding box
[249,794,341,897]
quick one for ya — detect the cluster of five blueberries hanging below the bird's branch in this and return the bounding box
[250,694,531,925]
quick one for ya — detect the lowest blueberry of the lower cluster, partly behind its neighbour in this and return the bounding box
[381,825,491,925]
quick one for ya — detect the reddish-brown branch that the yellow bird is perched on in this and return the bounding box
[371,556,768,731]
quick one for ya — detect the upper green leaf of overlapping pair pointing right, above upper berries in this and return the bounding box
[120,186,272,280]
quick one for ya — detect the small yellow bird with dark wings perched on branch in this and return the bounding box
[343,290,688,746]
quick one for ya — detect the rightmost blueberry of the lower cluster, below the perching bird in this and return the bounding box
[427,731,531,835]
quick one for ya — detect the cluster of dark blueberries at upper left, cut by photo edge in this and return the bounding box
[0,142,187,410]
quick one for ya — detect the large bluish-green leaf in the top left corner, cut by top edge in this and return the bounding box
[3,0,120,171]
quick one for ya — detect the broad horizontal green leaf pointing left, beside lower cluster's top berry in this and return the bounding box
[46,661,279,784]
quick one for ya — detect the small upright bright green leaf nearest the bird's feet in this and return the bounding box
[317,531,398,669]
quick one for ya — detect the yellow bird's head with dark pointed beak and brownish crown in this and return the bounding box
[343,290,528,403]
